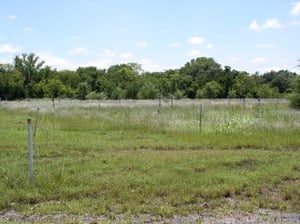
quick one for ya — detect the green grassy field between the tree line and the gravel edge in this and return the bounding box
[0,100,300,220]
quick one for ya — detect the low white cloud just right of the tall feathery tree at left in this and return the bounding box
[37,52,79,70]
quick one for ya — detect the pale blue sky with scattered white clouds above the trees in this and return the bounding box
[0,0,300,74]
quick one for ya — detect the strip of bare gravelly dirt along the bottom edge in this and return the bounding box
[0,209,300,224]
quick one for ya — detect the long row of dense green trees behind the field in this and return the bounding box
[0,53,299,103]
